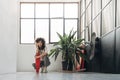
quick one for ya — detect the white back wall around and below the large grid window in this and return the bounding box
[17,0,79,71]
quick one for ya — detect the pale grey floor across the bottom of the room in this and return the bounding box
[0,72,120,80]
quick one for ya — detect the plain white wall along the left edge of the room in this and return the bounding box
[0,0,17,74]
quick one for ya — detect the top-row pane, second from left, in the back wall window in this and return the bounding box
[36,4,49,18]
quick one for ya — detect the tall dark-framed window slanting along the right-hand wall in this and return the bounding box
[80,0,116,41]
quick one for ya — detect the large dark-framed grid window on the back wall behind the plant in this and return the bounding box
[20,3,78,43]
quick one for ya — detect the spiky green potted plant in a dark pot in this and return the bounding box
[49,30,85,71]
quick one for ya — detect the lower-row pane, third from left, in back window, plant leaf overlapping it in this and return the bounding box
[50,19,63,42]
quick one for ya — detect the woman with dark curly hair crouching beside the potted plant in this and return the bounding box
[33,38,50,73]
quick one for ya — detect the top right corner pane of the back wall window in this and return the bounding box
[65,3,78,18]
